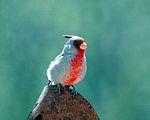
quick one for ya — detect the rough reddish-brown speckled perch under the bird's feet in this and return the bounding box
[27,86,99,120]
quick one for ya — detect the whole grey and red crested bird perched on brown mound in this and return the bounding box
[47,35,87,98]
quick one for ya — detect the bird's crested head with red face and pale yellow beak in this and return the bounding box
[64,35,87,52]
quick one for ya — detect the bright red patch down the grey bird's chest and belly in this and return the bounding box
[63,54,84,85]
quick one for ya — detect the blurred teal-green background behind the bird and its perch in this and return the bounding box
[0,0,150,120]
